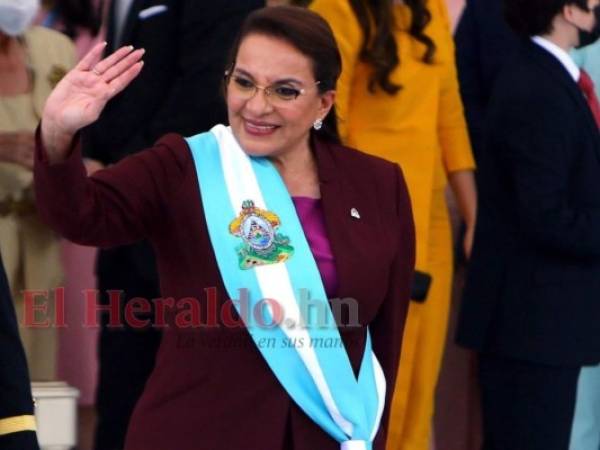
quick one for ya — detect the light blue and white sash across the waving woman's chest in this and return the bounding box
[187,125,386,450]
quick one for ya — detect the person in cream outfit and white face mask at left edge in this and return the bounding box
[0,0,75,380]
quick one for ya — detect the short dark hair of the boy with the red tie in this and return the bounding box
[504,0,588,36]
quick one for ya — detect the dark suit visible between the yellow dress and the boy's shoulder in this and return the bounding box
[454,0,518,160]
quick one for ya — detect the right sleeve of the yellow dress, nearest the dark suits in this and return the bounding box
[432,0,475,173]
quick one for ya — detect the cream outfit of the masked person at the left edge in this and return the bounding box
[0,27,75,380]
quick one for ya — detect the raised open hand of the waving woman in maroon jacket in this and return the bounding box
[42,43,144,162]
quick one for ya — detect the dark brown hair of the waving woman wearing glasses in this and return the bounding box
[226,6,342,143]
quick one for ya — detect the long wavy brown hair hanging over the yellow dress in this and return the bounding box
[349,0,436,95]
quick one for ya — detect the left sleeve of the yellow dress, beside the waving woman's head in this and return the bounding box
[310,0,362,142]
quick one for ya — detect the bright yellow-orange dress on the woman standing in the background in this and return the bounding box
[310,0,475,450]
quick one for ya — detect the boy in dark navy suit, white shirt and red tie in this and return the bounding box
[458,0,600,450]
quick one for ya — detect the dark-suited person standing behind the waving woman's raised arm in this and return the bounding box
[82,0,264,450]
